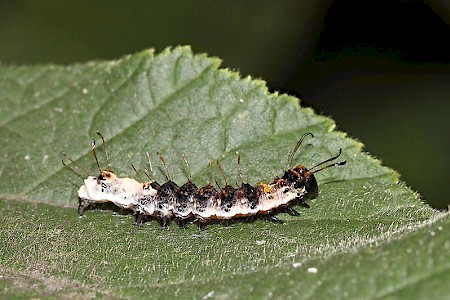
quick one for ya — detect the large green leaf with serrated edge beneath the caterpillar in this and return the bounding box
[0,47,444,298]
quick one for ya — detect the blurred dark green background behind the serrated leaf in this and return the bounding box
[0,0,450,209]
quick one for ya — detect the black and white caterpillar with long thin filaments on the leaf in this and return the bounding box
[62,131,346,229]
